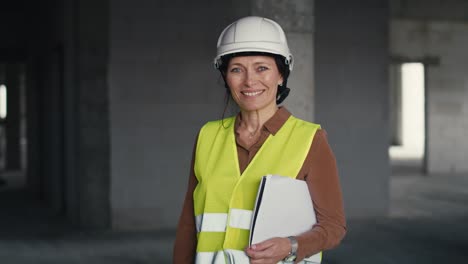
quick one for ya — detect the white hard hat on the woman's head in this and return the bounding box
[214,16,293,71]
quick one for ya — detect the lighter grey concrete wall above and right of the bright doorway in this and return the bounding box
[391,20,468,173]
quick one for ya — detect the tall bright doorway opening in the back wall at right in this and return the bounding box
[389,62,426,173]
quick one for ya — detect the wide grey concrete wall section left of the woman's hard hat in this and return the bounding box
[109,0,250,228]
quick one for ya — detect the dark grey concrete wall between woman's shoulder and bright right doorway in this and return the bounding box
[314,0,390,217]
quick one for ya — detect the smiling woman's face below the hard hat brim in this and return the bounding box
[226,56,283,111]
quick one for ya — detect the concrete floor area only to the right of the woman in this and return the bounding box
[324,173,468,264]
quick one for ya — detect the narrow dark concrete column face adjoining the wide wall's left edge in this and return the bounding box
[75,0,111,228]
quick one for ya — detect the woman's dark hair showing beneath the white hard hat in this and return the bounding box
[218,51,291,104]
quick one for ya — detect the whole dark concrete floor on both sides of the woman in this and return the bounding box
[0,172,468,264]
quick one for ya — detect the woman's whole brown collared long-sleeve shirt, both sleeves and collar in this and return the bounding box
[173,107,346,264]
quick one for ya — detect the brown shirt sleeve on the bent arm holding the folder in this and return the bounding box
[297,129,346,261]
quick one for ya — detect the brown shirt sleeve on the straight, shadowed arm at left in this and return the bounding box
[172,137,198,264]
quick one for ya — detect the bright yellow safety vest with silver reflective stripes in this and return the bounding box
[193,116,321,264]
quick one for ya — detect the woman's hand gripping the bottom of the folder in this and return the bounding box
[245,237,291,264]
